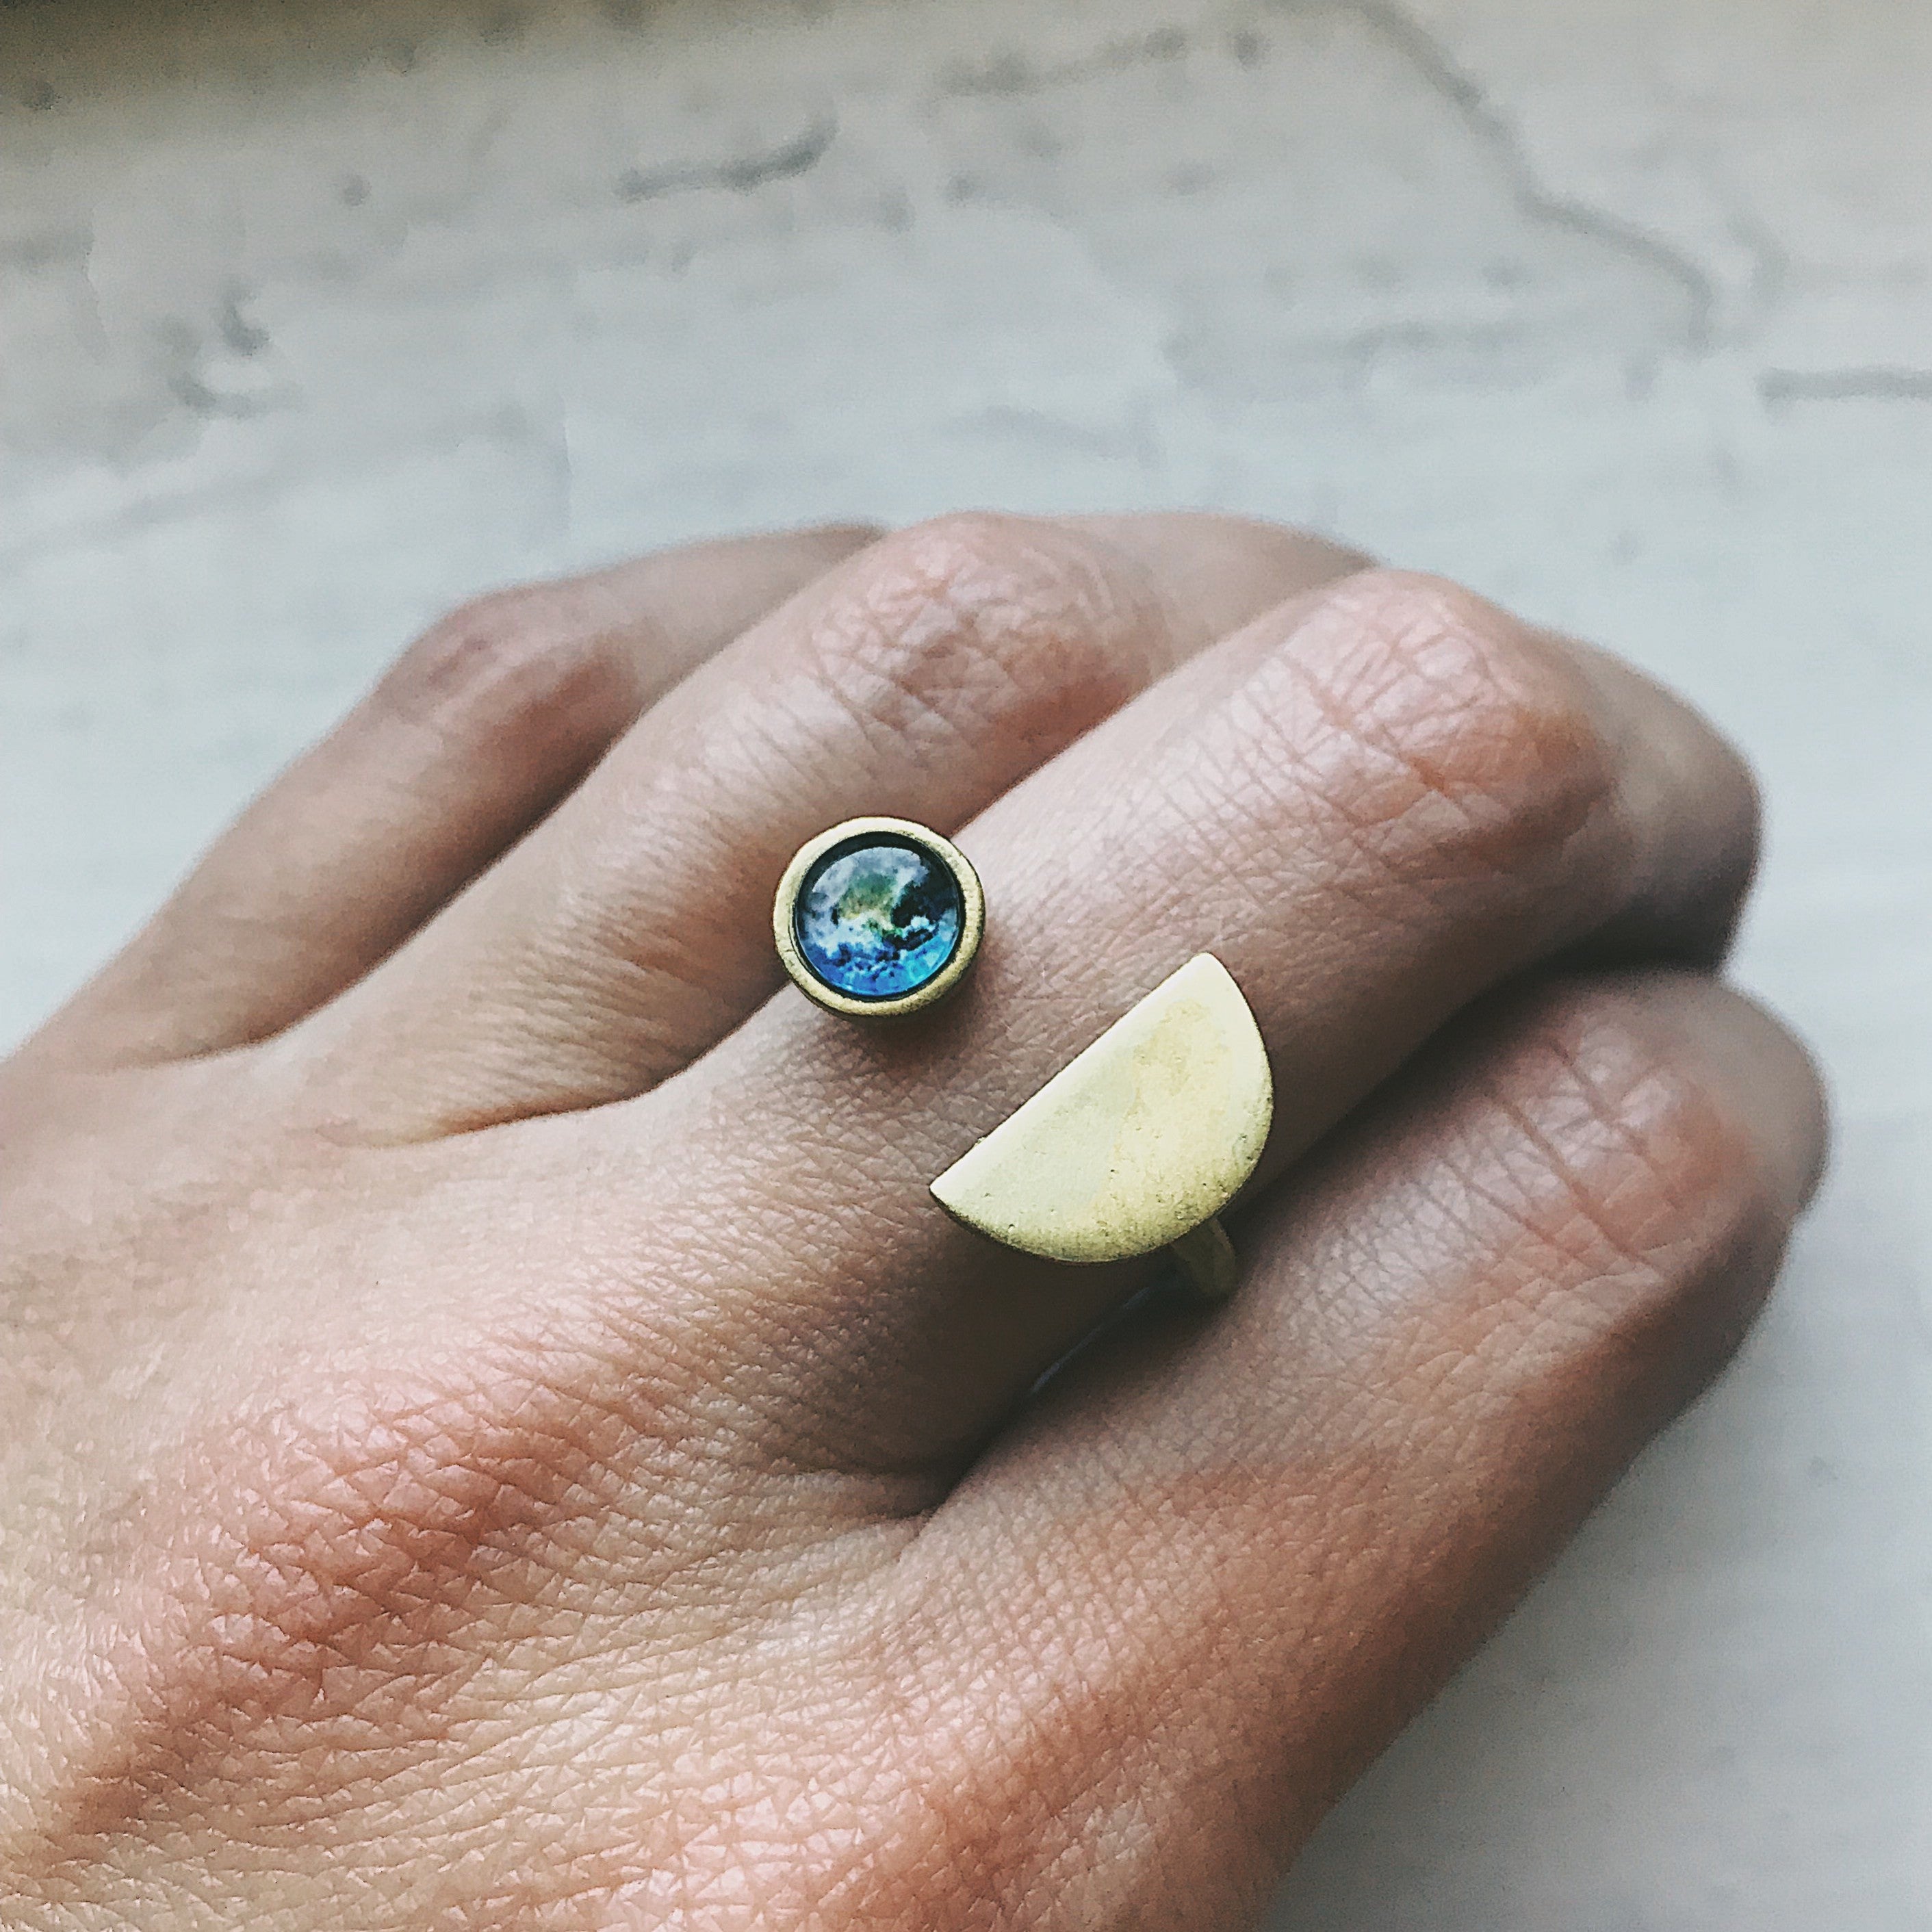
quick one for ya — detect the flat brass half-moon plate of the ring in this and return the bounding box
[933,953,1275,1261]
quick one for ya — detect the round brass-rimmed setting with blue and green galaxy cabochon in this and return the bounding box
[771,819,986,1020]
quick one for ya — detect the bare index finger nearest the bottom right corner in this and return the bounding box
[875,974,1824,1932]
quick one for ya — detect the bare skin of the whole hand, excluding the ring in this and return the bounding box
[0,516,1824,1932]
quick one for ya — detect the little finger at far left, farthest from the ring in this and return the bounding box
[24,530,873,1064]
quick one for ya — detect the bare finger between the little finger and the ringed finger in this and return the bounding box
[300,516,1360,1138]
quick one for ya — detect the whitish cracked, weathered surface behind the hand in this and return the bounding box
[0,0,1932,1932]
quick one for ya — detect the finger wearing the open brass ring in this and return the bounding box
[560,574,1754,1467]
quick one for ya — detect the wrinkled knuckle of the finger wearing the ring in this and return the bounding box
[1294,570,1615,883]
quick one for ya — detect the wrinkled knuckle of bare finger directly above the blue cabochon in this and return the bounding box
[815,512,1159,740]
